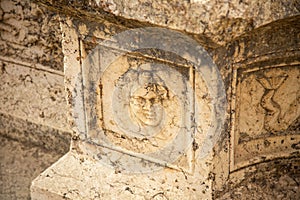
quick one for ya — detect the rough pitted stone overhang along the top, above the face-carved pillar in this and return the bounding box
[33,0,300,47]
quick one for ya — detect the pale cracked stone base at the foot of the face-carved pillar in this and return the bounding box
[31,152,211,200]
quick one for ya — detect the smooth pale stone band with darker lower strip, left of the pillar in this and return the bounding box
[0,57,71,152]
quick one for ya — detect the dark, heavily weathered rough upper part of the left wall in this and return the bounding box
[0,0,63,71]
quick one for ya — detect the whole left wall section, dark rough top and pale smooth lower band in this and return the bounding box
[0,0,70,152]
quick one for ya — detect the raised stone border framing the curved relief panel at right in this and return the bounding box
[230,56,300,172]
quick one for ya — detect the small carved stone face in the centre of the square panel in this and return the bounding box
[130,84,166,127]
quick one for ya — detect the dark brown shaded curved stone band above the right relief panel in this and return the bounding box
[213,15,300,65]
